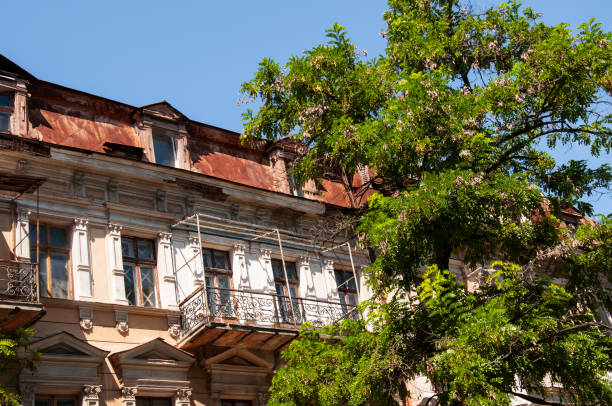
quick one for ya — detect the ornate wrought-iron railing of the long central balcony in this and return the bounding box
[179,287,359,335]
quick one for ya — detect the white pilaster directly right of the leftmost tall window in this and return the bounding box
[71,218,93,300]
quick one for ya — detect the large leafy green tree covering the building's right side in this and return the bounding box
[242,0,612,405]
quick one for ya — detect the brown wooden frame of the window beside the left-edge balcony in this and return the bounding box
[28,222,74,299]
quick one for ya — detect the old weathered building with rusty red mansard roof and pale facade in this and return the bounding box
[0,56,368,406]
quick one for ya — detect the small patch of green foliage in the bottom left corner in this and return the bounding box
[0,328,38,406]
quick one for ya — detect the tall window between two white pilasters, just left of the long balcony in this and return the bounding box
[121,237,157,307]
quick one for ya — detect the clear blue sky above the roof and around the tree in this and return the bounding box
[0,0,612,214]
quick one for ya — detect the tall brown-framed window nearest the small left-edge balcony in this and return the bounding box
[30,224,70,299]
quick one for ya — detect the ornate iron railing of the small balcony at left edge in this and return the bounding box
[0,259,38,303]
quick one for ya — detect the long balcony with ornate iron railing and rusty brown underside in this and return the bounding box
[179,286,359,351]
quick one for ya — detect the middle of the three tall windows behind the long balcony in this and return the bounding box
[271,259,300,323]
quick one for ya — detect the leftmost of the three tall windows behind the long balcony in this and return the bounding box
[202,248,234,317]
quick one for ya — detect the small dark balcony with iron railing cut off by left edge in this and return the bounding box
[0,260,45,332]
